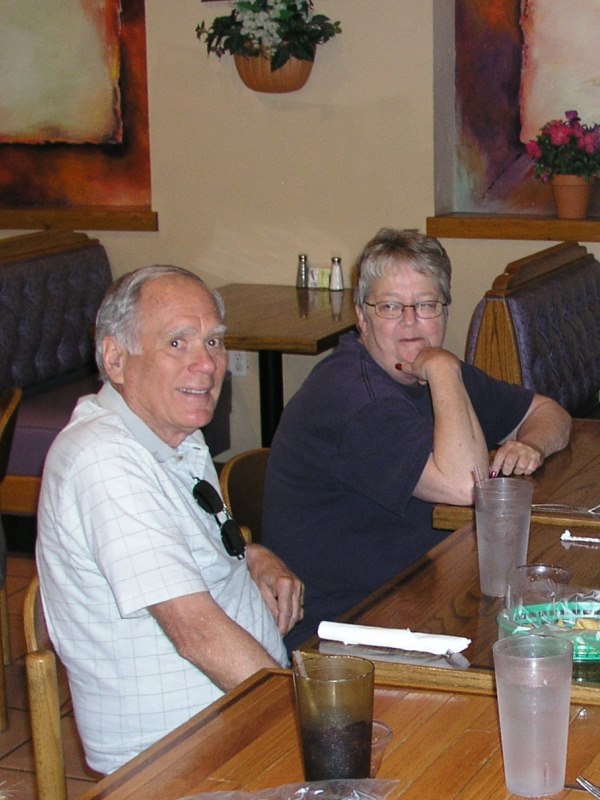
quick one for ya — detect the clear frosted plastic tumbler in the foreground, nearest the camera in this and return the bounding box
[493,634,573,797]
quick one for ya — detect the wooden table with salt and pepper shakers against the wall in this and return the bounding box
[218,283,356,447]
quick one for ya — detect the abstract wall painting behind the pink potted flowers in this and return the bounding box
[454,0,600,214]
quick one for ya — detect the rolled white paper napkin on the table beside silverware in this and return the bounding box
[317,620,471,655]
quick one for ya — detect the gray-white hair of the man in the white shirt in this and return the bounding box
[96,264,225,380]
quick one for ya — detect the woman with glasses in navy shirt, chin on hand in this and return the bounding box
[262,229,571,650]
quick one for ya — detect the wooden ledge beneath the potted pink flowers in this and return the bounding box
[426,213,600,242]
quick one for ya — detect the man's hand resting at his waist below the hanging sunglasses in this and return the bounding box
[246,544,304,636]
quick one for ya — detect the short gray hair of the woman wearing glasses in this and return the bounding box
[354,228,452,308]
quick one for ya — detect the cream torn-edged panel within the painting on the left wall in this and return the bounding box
[0,0,123,144]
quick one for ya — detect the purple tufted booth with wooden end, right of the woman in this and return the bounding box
[465,242,600,417]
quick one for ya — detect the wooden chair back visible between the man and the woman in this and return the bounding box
[219,447,270,543]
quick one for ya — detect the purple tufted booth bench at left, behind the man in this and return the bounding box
[0,231,231,515]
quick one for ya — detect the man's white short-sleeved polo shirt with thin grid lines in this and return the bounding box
[36,384,287,773]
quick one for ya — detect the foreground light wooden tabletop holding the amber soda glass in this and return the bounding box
[79,670,600,800]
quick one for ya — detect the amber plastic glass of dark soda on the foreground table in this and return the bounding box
[293,653,374,781]
